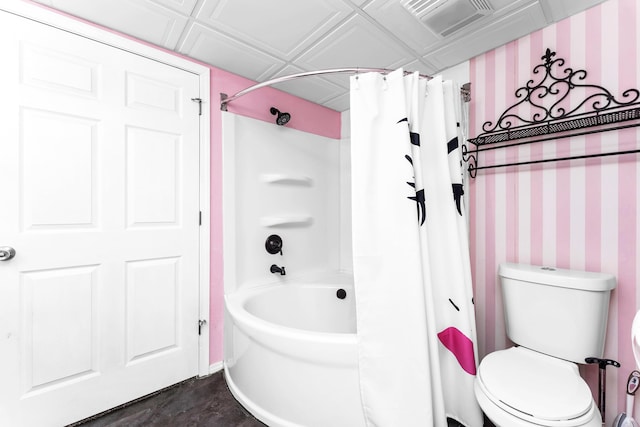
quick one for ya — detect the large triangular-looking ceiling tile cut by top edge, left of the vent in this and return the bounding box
[197,0,352,60]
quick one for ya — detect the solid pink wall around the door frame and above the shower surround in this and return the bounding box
[25,0,341,364]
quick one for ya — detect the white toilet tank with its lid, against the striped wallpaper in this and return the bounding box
[498,263,616,363]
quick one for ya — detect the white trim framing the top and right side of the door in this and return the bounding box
[0,1,211,376]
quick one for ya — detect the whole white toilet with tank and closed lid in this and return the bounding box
[474,264,616,427]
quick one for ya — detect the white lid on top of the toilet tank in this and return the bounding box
[498,263,616,291]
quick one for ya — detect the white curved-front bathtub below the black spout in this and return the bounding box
[225,275,365,427]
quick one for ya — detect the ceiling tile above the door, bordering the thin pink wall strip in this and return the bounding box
[45,0,188,49]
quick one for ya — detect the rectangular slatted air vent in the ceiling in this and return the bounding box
[402,0,493,37]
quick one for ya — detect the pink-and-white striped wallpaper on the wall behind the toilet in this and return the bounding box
[469,0,640,425]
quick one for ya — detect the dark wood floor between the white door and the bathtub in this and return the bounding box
[72,372,265,427]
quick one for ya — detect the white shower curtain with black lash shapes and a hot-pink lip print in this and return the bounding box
[351,70,482,427]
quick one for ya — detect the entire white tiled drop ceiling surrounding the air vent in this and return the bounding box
[35,0,604,111]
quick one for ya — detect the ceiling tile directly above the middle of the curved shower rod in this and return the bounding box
[296,16,413,70]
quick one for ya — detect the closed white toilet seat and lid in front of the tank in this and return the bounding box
[476,347,597,426]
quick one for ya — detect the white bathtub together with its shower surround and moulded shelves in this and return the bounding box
[223,113,364,427]
